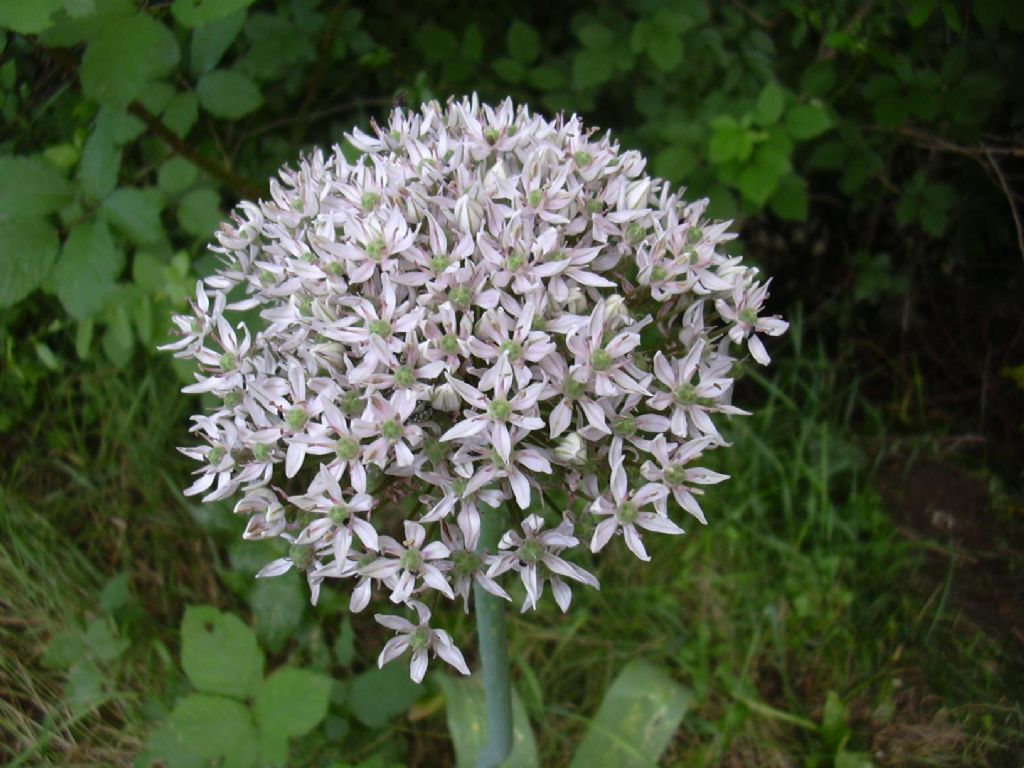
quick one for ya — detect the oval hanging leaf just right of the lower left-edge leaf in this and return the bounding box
[53,220,124,319]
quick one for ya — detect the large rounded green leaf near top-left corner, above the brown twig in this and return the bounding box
[79,13,178,108]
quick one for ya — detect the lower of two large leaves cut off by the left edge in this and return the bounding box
[0,218,60,308]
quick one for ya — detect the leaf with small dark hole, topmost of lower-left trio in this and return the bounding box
[181,605,263,698]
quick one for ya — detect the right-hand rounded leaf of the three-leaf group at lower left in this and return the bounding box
[255,667,333,738]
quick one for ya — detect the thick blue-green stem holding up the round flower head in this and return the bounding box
[473,507,512,768]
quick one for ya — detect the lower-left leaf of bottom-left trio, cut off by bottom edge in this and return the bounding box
[168,693,258,768]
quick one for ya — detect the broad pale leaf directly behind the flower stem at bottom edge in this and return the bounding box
[437,674,541,768]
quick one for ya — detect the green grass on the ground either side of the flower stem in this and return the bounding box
[0,325,1024,766]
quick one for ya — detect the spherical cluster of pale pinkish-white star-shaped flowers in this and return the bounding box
[165,97,786,679]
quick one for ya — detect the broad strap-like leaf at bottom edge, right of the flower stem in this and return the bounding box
[570,660,692,768]
